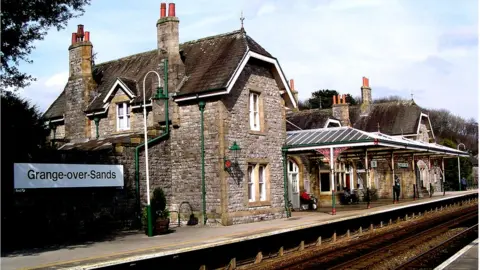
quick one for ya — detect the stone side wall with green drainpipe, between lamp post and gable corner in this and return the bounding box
[171,101,221,222]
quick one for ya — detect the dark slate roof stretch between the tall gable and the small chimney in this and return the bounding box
[286,109,335,131]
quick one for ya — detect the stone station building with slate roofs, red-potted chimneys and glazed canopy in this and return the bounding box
[44,3,463,229]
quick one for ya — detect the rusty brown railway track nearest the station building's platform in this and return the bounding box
[245,201,478,269]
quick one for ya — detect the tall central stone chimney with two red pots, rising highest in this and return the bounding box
[157,3,185,93]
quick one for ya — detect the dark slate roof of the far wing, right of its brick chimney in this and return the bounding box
[351,101,422,135]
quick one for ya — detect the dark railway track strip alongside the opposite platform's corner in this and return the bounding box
[395,223,478,270]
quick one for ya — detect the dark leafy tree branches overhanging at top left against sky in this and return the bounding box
[0,0,90,90]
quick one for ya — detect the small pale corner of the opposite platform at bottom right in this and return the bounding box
[434,238,478,270]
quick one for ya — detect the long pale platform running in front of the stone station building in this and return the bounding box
[1,190,478,270]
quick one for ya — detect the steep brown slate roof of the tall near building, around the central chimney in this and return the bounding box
[44,30,273,119]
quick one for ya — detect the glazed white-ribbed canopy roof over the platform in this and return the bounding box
[284,127,469,157]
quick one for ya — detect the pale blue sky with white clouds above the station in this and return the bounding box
[16,0,479,121]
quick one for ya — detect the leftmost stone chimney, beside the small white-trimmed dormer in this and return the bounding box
[65,24,95,140]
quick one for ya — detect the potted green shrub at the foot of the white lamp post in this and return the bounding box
[150,188,170,234]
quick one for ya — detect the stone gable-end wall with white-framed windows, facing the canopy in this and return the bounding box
[222,60,286,224]
